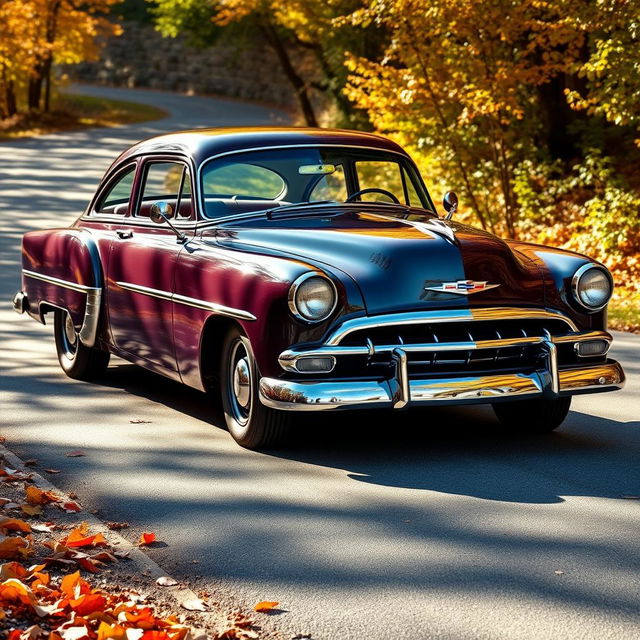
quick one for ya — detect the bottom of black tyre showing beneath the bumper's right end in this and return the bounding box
[493,396,571,433]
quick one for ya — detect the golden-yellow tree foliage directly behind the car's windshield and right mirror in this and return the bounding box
[347,0,596,237]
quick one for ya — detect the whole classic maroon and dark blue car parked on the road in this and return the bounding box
[13,128,625,448]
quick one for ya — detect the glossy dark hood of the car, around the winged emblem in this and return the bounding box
[216,210,545,314]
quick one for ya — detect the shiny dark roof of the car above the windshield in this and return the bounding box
[114,127,407,164]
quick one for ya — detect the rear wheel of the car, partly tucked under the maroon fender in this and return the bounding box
[53,309,110,380]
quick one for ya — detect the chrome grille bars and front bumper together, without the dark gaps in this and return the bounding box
[260,307,625,411]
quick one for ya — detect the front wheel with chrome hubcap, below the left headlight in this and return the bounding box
[220,328,291,449]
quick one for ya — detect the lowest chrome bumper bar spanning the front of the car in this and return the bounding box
[260,360,625,411]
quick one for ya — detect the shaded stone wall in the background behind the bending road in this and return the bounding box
[67,22,295,108]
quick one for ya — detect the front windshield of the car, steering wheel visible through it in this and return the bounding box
[201,147,433,218]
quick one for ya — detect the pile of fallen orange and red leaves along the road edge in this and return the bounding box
[0,469,191,640]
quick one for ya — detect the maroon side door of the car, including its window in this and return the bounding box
[107,158,194,377]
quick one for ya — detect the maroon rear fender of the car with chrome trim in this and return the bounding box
[22,229,104,347]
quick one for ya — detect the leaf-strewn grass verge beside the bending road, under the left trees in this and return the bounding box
[0,93,167,140]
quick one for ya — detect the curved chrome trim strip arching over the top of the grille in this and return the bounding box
[325,307,578,345]
